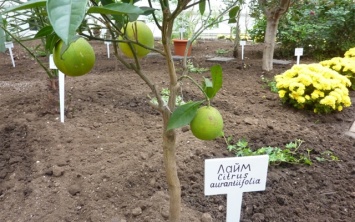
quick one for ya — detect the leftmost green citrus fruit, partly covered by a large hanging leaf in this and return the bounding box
[53,38,95,76]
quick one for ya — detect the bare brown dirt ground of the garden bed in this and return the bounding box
[0,40,355,222]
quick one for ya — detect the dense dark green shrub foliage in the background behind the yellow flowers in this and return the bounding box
[250,0,355,60]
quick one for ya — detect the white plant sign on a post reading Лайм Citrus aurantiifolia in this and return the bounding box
[205,155,269,222]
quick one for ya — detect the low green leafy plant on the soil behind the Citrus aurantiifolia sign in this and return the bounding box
[227,137,312,165]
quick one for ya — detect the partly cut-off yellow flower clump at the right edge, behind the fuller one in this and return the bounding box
[320,57,355,75]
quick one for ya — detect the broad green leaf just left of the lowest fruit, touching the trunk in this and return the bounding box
[167,101,204,130]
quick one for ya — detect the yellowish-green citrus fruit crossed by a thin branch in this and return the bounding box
[118,21,154,58]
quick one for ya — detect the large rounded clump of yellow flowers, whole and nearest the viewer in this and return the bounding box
[275,64,351,112]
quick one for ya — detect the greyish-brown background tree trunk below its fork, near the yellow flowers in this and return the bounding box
[262,18,279,71]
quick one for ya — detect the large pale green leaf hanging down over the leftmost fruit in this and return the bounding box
[47,0,87,45]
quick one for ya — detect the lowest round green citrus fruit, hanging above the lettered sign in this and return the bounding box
[190,106,223,140]
